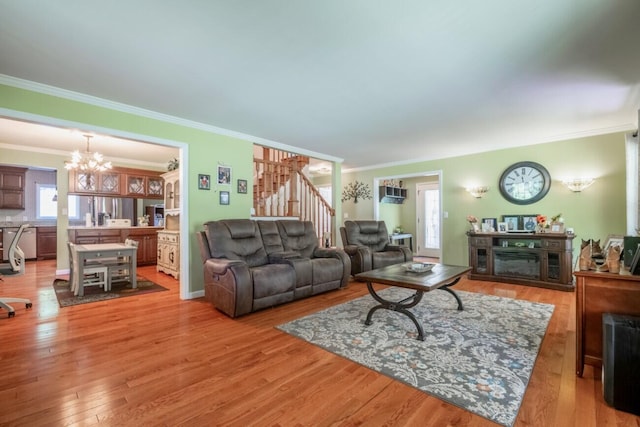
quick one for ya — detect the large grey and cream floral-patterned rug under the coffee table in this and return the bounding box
[277,288,554,427]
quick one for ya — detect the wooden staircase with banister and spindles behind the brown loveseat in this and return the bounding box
[253,147,335,246]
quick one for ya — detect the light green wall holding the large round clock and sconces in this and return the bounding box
[342,133,626,264]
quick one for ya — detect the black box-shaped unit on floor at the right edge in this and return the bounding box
[602,313,640,415]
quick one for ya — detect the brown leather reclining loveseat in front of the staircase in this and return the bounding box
[197,219,351,317]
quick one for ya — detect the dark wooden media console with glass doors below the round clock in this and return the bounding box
[467,231,574,291]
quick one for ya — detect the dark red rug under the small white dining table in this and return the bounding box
[53,277,168,307]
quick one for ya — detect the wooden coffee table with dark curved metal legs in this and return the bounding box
[355,264,471,341]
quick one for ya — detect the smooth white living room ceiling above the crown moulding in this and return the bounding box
[0,0,640,169]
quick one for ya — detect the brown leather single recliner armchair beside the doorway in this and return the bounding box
[340,220,413,275]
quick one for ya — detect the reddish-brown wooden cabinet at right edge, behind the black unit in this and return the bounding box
[573,271,640,377]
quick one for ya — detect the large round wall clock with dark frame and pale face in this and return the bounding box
[499,162,551,205]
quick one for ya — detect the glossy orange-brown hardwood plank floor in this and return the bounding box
[0,261,640,427]
